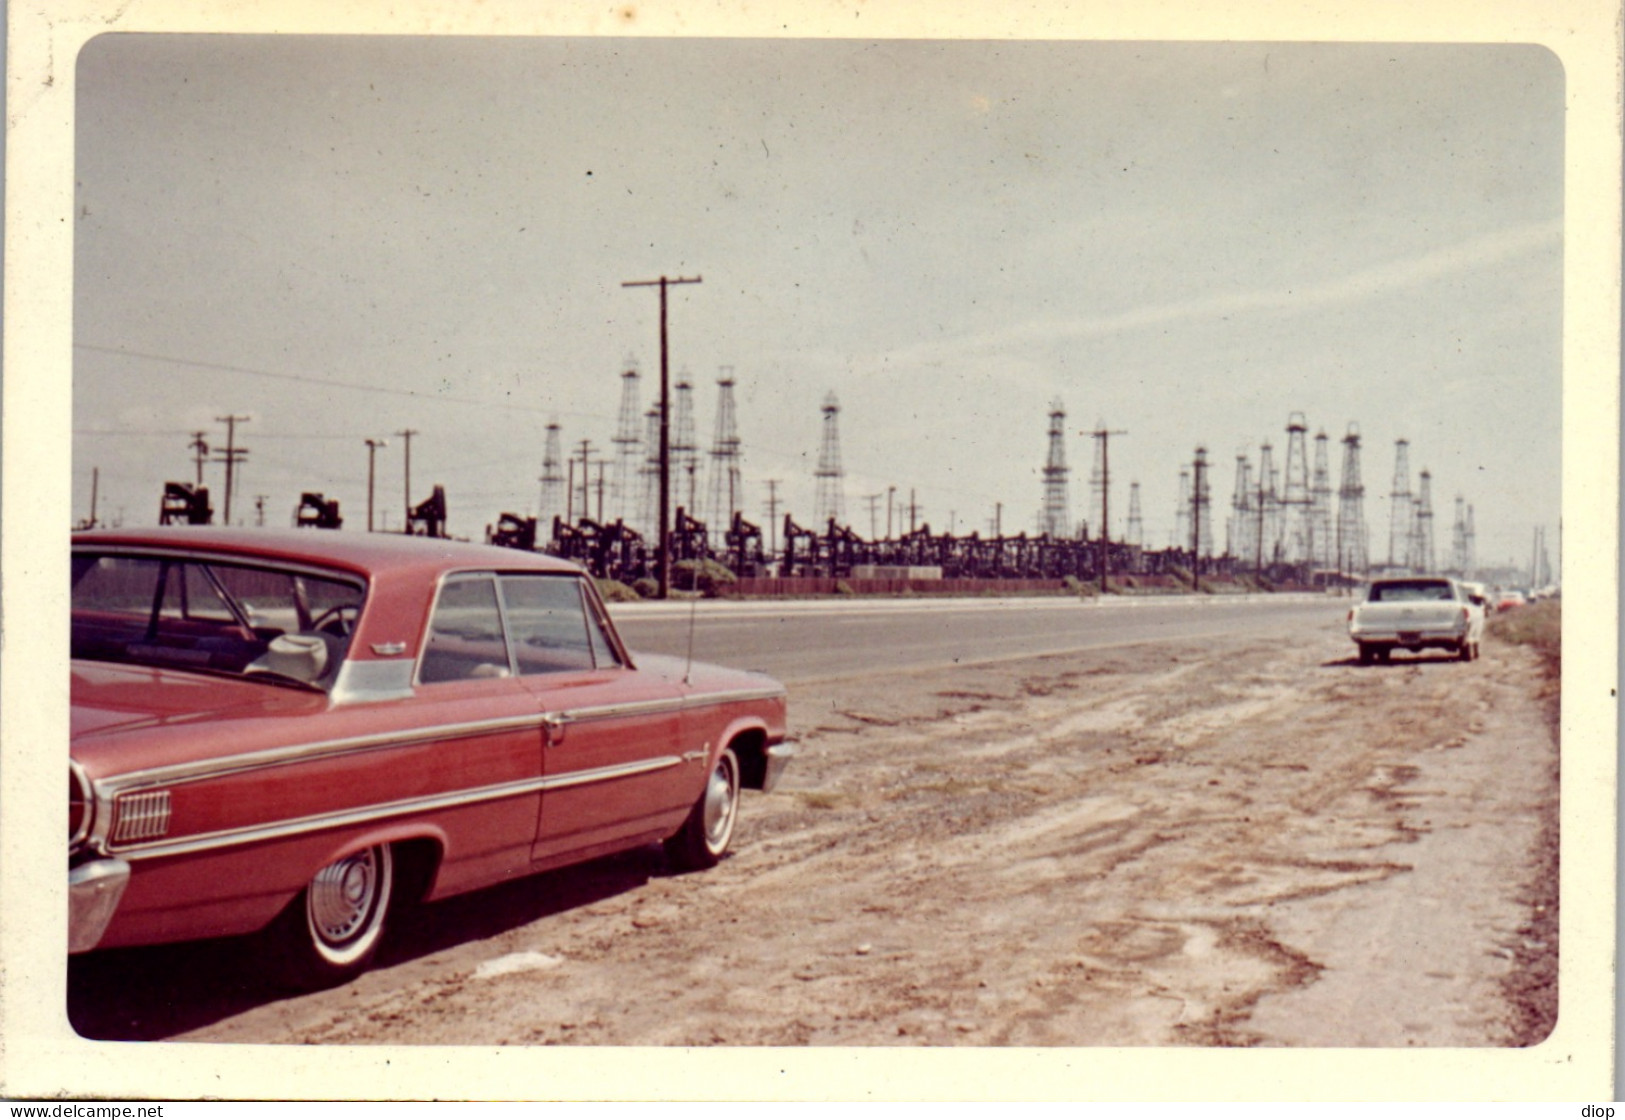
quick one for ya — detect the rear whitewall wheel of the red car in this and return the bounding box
[268,844,395,990]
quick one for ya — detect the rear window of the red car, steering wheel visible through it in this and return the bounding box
[72,553,366,686]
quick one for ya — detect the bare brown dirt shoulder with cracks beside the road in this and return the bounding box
[80,607,1557,1047]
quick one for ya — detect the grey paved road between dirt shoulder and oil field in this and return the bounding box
[613,595,1347,683]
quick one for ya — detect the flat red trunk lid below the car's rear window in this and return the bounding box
[70,662,327,743]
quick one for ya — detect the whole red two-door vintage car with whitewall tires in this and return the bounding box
[68,528,791,987]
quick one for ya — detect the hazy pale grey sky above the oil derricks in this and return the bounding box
[73,34,1563,564]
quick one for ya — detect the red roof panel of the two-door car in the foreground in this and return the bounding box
[73,525,580,575]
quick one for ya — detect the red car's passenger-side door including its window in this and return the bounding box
[499,572,700,865]
